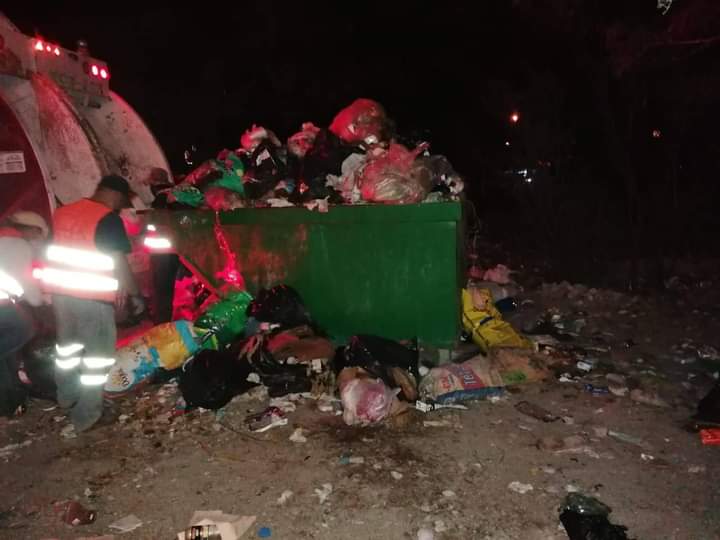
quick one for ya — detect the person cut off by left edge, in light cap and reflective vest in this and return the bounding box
[0,212,48,416]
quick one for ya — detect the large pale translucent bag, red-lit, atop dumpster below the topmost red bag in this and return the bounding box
[359,144,432,204]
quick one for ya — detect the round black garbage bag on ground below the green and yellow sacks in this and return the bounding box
[180,347,255,410]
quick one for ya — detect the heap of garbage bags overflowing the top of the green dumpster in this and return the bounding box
[167,99,464,212]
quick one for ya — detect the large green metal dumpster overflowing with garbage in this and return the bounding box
[155,203,462,347]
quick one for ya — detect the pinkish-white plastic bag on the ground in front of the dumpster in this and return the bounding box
[338,368,399,426]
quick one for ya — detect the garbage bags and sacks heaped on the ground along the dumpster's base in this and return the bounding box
[98,274,560,429]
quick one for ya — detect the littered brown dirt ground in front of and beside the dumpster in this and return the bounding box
[0,276,720,540]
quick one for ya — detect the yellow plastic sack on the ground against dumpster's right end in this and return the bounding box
[462,288,532,354]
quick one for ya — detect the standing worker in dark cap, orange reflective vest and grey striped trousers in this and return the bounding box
[37,175,145,431]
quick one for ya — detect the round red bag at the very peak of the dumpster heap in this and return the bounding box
[330,98,388,144]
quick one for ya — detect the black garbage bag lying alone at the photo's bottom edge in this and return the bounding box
[560,493,628,540]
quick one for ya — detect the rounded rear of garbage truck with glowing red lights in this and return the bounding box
[0,13,170,224]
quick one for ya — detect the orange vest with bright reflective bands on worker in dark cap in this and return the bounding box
[33,199,118,302]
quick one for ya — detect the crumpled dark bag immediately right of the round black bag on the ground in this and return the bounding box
[240,335,312,397]
